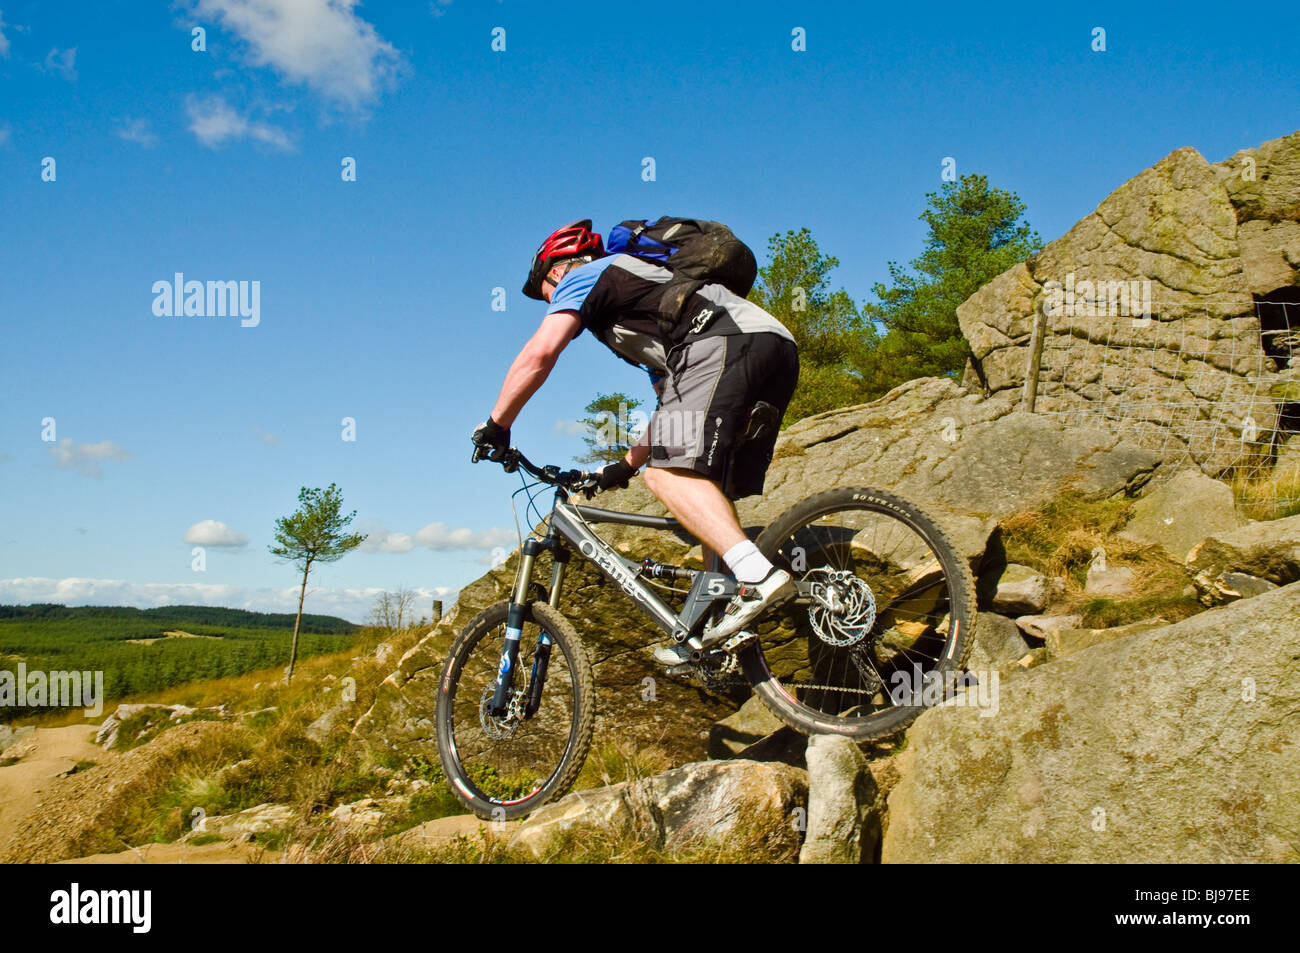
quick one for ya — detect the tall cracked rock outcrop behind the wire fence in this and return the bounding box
[957,133,1300,476]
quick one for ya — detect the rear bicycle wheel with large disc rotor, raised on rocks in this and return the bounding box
[740,488,975,741]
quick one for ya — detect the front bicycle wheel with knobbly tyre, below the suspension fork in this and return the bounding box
[436,602,595,820]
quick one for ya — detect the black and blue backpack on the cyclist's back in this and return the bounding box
[605,216,758,333]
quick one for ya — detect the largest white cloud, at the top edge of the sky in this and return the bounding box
[195,0,402,109]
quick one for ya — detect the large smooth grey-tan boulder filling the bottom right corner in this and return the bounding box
[883,584,1300,863]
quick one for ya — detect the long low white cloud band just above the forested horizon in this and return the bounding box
[0,577,459,623]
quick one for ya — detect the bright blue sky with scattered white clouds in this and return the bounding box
[0,0,1300,620]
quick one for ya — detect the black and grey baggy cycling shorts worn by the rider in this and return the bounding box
[649,332,800,499]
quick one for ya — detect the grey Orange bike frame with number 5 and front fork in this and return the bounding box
[491,488,736,716]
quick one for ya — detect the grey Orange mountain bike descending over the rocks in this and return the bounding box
[436,447,975,820]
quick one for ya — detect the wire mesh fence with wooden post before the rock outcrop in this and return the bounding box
[1024,297,1300,519]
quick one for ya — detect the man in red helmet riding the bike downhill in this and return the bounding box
[473,220,798,666]
